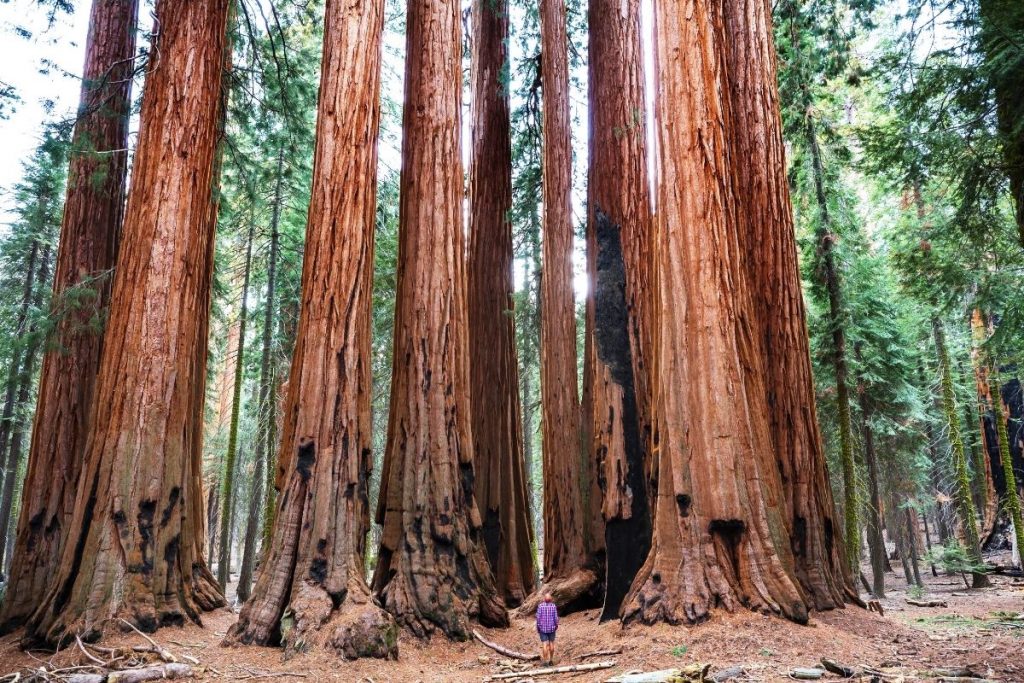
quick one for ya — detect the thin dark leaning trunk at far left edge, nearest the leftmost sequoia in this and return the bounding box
[0,245,50,568]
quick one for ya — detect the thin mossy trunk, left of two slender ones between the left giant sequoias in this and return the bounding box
[217,226,254,590]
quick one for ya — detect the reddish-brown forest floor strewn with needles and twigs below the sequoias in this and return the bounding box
[0,558,1024,683]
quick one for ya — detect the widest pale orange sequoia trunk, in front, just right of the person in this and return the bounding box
[624,0,807,624]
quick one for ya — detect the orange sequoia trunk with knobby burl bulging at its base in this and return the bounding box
[227,0,398,658]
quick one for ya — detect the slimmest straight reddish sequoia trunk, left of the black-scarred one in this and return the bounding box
[526,0,597,610]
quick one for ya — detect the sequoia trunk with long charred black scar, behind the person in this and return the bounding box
[585,0,653,618]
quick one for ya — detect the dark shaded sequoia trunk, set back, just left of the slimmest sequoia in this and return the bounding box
[467,0,535,606]
